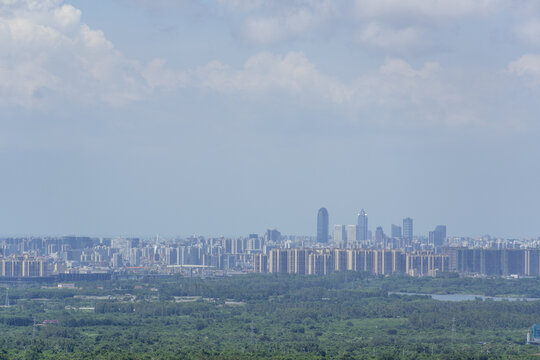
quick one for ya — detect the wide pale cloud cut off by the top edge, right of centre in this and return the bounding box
[214,0,511,49]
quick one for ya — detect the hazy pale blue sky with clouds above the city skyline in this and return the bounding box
[0,0,540,237]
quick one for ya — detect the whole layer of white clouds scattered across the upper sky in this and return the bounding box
[0,0,540,129]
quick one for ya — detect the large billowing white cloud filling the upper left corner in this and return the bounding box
[0,0,146,106]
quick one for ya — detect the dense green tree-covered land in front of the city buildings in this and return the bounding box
[0,273,540,360]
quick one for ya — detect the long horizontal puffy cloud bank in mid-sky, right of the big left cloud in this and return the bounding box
[142,52,468,124]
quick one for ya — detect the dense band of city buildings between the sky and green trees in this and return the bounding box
[5,225,540,282]
